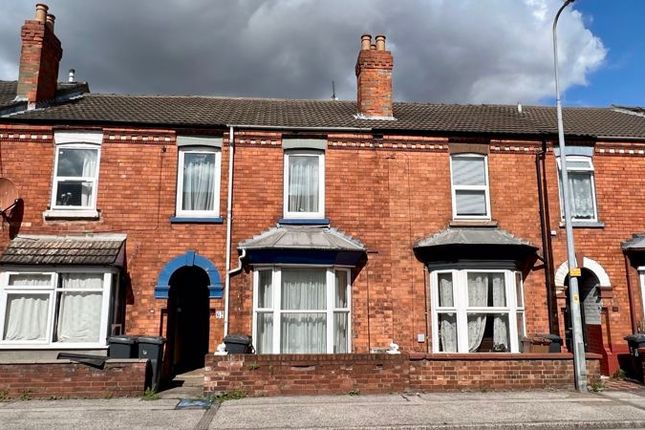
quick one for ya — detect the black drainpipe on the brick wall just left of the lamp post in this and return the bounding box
[535,141,560,336]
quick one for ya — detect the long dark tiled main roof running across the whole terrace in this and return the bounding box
[5,93,645,138]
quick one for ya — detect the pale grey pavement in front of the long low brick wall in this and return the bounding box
[210,392,645,429]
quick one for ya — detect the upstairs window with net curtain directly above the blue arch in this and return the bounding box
[177,147,221,217]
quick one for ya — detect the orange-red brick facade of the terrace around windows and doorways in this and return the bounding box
[0,125,645,376]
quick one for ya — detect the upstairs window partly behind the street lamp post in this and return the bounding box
[557,155,598,222]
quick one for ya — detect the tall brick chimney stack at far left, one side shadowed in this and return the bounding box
[17,3,63,105]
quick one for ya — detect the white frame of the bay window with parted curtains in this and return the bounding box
[430,269,526,354]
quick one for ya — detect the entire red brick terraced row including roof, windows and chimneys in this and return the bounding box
[0,6,645,396]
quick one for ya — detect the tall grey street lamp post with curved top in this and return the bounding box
[553,0,587,392]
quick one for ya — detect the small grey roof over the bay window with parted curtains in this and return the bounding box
[414,227,537,249]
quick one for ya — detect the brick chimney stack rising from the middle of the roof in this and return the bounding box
[356,34,394,119]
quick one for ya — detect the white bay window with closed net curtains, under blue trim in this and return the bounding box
[253,267,351,354]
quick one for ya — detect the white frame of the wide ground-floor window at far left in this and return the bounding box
[0,267,116,350]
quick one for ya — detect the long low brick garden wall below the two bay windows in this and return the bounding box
[204,354,600,396]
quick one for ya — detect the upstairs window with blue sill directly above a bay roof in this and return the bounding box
[284,150,325,219]
